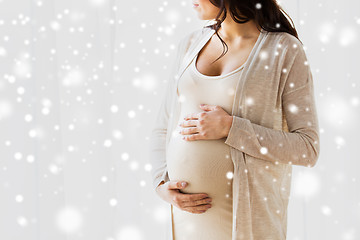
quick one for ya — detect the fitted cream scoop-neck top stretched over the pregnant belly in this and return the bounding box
[166,56,244,240]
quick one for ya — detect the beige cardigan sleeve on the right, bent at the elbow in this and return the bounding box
[225,42,320,167]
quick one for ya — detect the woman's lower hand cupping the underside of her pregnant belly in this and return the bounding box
[156,181,211,213]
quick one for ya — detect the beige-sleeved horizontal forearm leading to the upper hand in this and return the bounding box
[225,116,319,167]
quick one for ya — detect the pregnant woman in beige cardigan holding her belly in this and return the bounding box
[150,0,320,240]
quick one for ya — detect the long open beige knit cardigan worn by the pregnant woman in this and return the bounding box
[150,24,320,240]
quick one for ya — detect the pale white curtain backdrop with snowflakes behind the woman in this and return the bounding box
[0,0,360,240]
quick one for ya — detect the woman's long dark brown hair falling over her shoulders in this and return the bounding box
[204,0,303,62]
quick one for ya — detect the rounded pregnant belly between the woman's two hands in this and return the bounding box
[166,124,234,198]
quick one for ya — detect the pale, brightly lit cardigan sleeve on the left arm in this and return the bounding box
[149,34,191,190]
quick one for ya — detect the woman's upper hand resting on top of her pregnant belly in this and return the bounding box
[179,104,232,141]
